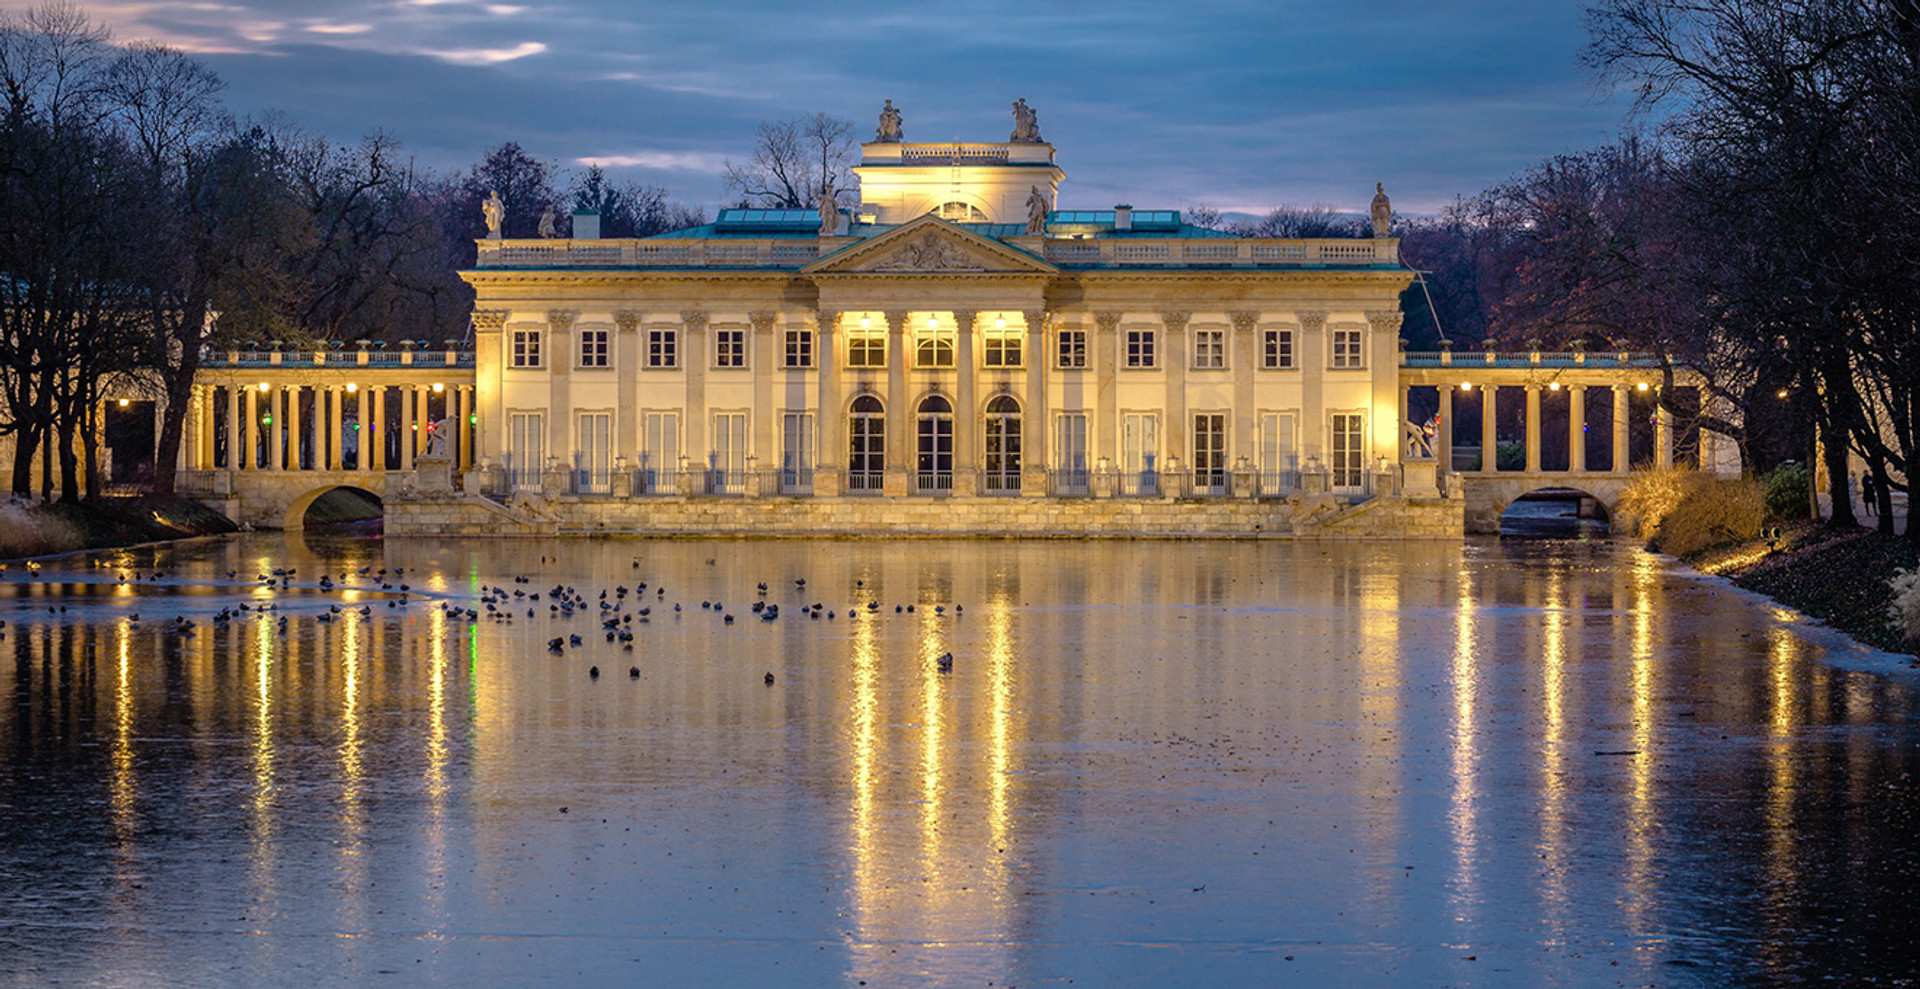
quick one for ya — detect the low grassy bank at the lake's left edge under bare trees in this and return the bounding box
[0,495,234,559]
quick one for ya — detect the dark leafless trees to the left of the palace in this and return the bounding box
[0,4,701,499]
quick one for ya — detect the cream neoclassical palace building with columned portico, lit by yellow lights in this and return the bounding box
[465,131,1411,499]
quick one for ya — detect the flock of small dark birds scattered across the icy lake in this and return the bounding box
[0,557,966,686]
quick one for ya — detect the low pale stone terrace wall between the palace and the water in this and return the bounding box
[386,495,1465,540]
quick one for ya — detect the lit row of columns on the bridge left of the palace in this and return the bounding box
[182,380,474,472]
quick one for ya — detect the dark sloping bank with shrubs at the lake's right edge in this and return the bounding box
[1682,522,1914,653]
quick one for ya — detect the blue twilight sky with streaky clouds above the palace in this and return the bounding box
[18,0,1626,213]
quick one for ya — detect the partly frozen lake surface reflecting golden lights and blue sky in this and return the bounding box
[0,534,1920,987]
